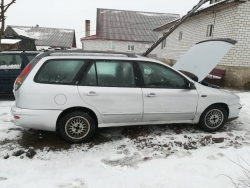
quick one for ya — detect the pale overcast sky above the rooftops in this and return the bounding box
[5,0,202,47]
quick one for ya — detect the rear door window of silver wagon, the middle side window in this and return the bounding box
[83,60,136,87]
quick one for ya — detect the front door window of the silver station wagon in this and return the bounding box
[139,62,188,89]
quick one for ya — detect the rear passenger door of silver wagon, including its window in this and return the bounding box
[78,60,143,123]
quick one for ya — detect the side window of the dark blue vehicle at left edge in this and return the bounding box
[0,54,23,69]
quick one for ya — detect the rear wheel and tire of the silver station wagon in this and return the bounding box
[59,111,96,143]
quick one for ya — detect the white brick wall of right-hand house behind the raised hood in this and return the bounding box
[157,1,250,67]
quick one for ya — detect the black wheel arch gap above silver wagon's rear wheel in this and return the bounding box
[56,106,98,131]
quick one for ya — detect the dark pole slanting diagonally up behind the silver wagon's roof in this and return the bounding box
[142,0,210,56]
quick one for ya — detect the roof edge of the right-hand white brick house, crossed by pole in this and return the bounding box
[154,0,247,31]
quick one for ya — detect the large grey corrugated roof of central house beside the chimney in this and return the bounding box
[96,8,180,42]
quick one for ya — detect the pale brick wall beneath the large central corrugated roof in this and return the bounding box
[82,40,157,54]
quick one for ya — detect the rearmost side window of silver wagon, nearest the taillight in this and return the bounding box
[34,59,85,85]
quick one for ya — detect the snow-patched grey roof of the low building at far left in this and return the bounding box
[5,26,76,47]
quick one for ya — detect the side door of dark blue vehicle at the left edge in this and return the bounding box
[0,53,27,93]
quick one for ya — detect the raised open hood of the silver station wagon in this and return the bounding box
[173,39,237,82]
